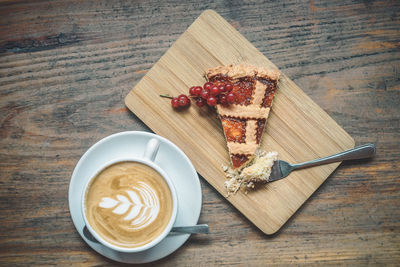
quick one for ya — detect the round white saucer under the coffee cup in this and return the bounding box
[68,131,202,263]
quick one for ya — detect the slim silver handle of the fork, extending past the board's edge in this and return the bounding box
[293,144,376,169]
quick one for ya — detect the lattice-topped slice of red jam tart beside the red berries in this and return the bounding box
[206,64,279,170]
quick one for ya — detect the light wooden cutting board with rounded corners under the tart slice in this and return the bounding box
[125,10,354,234]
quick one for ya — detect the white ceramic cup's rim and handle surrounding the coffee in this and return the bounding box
[81,138,178,253]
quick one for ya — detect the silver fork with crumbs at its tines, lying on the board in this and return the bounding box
[268,144,376,182]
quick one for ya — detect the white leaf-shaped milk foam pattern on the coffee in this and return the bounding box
[99,182,160,229]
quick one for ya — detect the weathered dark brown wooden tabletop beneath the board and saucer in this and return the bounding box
[0,0,400,266]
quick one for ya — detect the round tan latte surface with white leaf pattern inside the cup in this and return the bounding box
[85,161,173,248]
